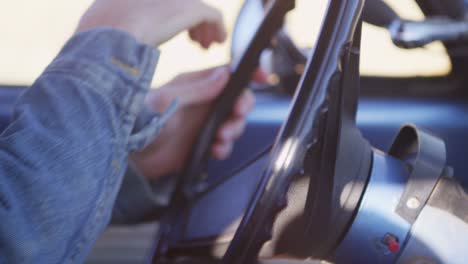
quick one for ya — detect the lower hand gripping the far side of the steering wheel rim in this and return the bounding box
[131,67,265,179]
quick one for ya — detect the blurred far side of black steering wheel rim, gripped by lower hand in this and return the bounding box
[155,0,294,256]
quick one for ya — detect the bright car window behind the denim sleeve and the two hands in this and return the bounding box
[0,0,240,85]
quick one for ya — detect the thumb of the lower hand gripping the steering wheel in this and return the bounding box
[176,66,229,105]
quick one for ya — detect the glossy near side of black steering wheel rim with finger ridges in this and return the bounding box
[155,0,370,263]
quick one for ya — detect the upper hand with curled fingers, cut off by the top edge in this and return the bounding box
[77,0,226,48]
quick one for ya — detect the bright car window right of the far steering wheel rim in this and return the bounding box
[287,0,451,77]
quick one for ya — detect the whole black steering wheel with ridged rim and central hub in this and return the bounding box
[152,0,371,263]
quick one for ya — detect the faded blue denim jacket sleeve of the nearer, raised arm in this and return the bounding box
[0,28,170,263]
